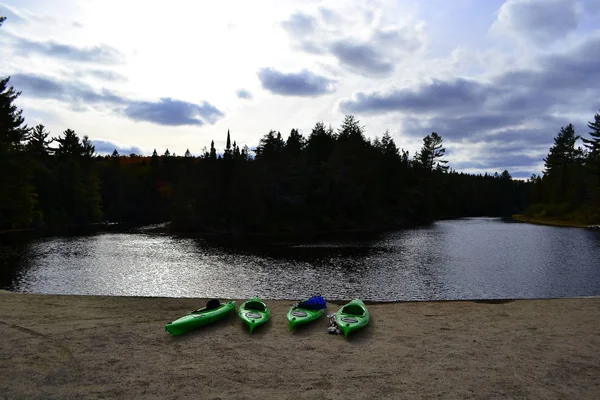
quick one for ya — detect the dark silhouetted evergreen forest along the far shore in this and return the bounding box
[0,15,600,235]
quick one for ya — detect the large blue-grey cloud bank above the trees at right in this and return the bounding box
[338,33,600,175]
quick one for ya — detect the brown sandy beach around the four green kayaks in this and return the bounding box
[0,291,600,399]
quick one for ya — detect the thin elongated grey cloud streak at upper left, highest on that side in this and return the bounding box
[6,34,124,64]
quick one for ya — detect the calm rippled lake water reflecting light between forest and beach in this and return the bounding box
[0,218,600,301]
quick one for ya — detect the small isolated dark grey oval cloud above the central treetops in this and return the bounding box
[258,68,335,97]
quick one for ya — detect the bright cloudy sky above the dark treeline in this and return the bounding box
[0,0,600,177]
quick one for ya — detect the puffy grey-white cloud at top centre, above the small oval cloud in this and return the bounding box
[281,7,424,77]
